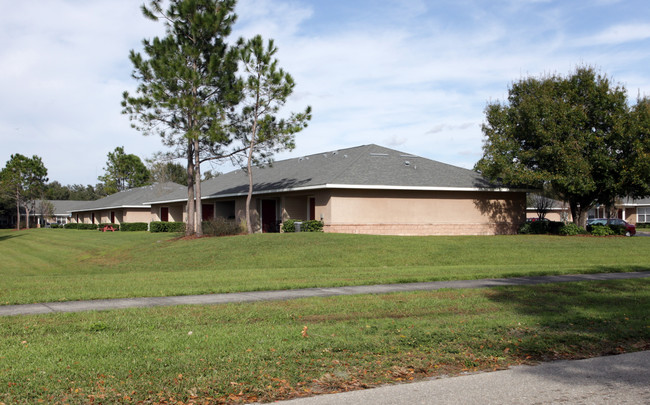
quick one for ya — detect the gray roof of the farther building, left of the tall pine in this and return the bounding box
[70,182,187,212]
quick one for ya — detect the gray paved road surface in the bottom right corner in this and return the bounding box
[281,351,650,405]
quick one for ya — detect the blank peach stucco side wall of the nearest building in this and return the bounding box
[316,190,526,235]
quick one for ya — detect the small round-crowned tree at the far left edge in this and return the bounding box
[0,153,48,229]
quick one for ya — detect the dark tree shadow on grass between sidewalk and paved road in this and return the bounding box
[490,279,650,384]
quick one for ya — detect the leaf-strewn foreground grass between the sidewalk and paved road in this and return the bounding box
[0,280,650,404]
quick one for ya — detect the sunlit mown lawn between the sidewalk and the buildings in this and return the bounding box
[0,229,650,305]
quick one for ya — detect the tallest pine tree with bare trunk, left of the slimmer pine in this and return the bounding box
[122,0,240,234]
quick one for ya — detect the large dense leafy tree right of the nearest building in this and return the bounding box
[475,67,650,225]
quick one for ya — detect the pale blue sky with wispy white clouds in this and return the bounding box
[0,0,650,184]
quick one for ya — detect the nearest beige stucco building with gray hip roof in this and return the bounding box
[146,145,526,235]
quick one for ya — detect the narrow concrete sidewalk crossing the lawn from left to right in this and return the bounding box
[0,271,650,316]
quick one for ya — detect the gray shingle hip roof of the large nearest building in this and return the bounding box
[150,145,498,203]
